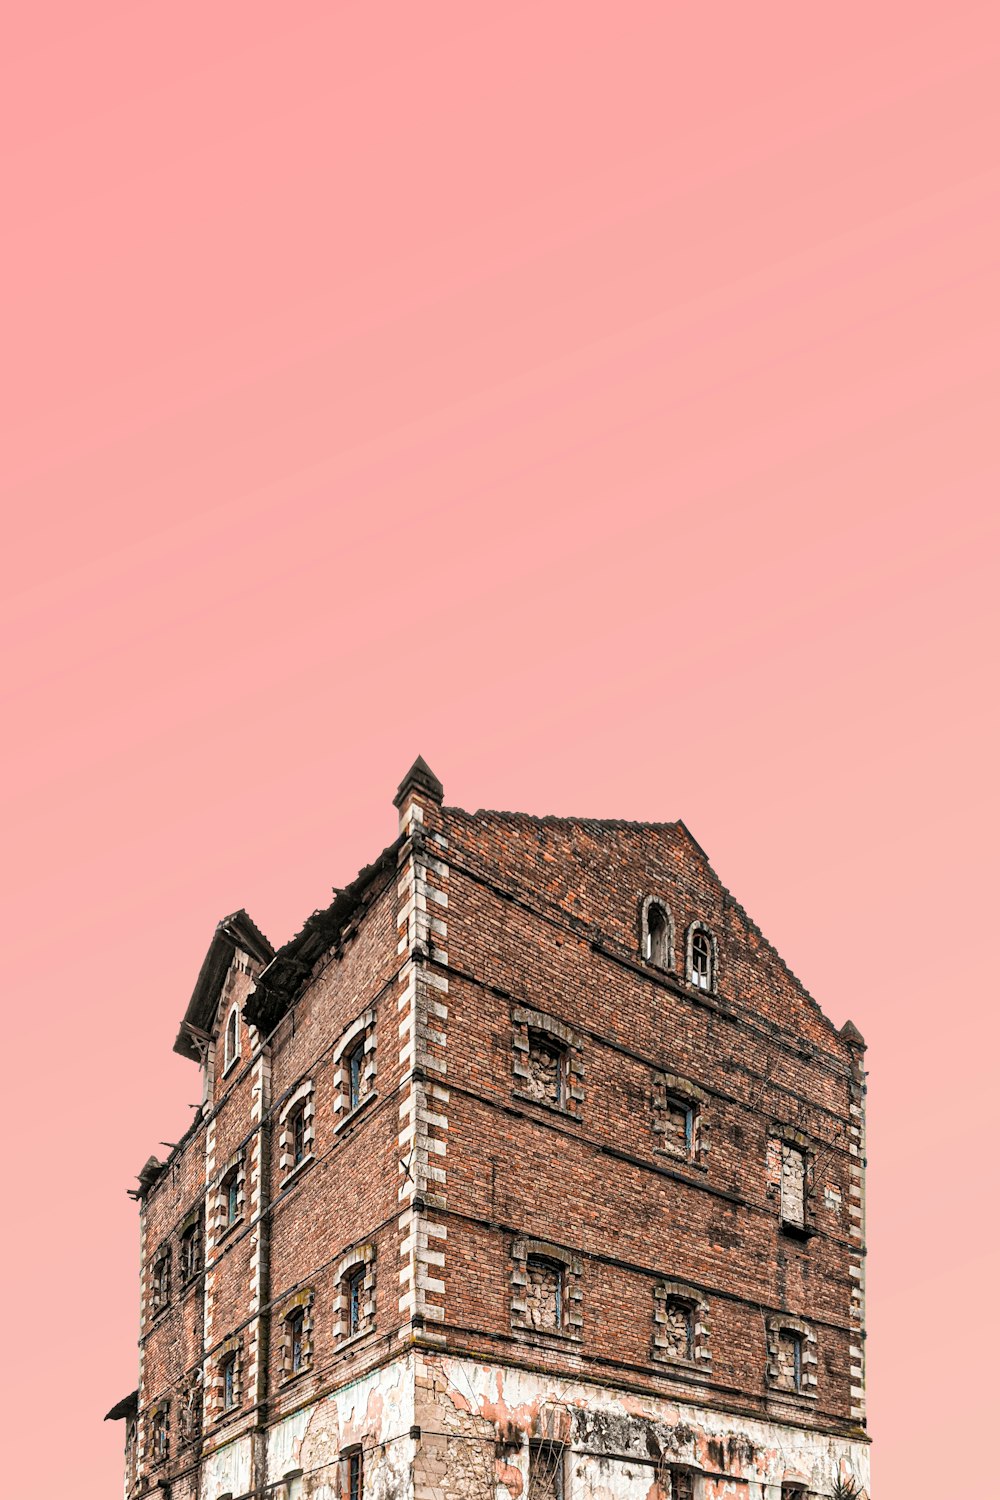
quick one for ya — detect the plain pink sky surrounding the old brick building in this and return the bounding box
[0,0,1000,1500]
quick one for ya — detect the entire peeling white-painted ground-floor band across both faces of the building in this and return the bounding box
[199,1350,870,1500]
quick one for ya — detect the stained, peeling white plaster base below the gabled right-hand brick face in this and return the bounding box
[414,1356,870,1500]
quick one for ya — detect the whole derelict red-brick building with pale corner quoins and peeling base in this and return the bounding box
[109,761,868,1500]
